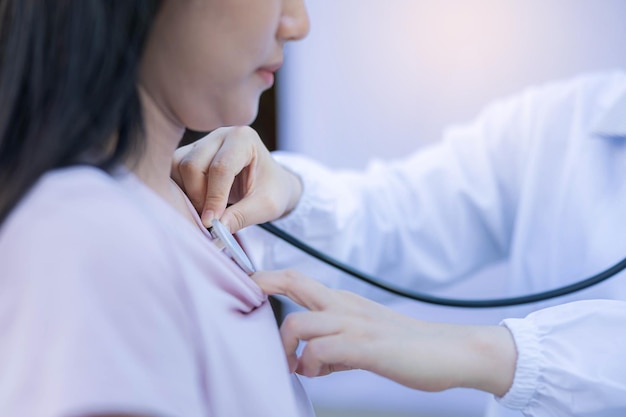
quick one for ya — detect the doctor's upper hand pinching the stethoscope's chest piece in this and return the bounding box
[171,126,302,233]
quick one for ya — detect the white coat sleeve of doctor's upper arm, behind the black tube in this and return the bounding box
[250,84,540,298]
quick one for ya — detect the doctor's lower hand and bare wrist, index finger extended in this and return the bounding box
[253,270,517,396]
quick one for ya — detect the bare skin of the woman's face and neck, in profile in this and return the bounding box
[139,0,309,226]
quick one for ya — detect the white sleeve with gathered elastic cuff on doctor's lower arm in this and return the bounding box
[499,300,626,417]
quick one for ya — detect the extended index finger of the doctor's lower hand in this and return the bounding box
[252,269,332,311]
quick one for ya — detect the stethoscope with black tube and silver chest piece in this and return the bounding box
[209,220,626,308]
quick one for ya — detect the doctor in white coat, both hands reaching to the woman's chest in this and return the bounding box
[172,71,626,417]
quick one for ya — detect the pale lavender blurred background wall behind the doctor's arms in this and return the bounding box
[277,0,626,417]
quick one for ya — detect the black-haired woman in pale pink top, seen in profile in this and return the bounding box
[0,0,312,417]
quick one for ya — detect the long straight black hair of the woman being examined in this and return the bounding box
[0,0,161,225]
